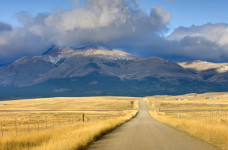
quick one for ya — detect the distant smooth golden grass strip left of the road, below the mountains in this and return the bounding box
[0,97,137,111]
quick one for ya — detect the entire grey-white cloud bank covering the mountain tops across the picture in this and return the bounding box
[0,0,228,63]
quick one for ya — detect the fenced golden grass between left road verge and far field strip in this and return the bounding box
[0,111,128,136]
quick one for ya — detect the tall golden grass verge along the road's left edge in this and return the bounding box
[32,111,137,150]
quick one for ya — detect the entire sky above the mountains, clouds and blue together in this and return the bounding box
[0,0,228,64]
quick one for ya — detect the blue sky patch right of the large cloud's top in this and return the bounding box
[142,0,228,30]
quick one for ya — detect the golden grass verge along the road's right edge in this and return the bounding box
[150,111,228,150]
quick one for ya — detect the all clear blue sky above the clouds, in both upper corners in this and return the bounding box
[0,0,228,31]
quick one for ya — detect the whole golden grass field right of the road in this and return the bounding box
[147,93,228,150]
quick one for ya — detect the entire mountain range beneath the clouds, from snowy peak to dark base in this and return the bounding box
[0,46,228,99]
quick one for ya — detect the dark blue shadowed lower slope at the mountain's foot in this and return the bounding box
[0,72,221,99]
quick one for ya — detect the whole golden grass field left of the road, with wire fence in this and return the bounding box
[0,97,138,150]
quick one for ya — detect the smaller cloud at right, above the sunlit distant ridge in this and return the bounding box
[167,23,228,62]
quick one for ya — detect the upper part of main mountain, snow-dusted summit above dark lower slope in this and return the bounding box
[0,47,199,87]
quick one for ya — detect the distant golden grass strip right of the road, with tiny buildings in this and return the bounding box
[145,92,228,110]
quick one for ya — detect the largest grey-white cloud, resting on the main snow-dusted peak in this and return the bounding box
[0,0,170,63]
